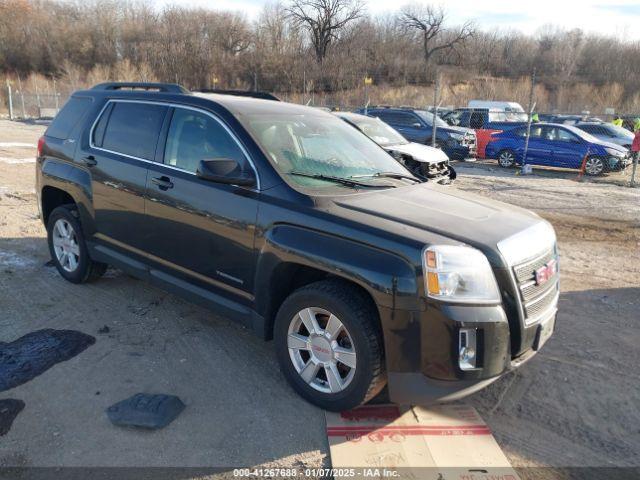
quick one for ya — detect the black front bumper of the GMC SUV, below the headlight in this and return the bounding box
[381,304,555,405]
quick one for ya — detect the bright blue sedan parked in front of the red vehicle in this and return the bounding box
[486,123,631,175]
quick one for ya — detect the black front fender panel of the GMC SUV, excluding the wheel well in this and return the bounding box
[255,225,421,315]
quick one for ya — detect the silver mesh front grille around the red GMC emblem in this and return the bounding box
[513,249,559,324]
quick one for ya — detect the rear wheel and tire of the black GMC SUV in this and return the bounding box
[47,205,107,283]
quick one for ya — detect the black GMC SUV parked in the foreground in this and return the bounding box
[36,83,558,410]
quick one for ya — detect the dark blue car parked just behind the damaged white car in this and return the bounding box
[357,107,476,160]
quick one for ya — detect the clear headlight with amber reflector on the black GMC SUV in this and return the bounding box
[422,245,500,303]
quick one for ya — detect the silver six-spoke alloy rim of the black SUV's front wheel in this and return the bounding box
[287,307,357,393]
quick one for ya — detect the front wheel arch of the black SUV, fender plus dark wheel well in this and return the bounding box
[254,225,420,339]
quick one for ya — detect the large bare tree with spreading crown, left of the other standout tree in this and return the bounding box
[287,0,364,63]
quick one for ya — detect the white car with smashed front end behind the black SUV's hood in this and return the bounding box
[334,112,456,184]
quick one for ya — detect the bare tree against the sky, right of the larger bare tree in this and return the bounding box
[399,4,475,65]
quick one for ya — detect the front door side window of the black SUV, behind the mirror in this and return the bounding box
[164,108,245,173]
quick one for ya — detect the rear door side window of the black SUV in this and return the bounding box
[102,102,167,160]
